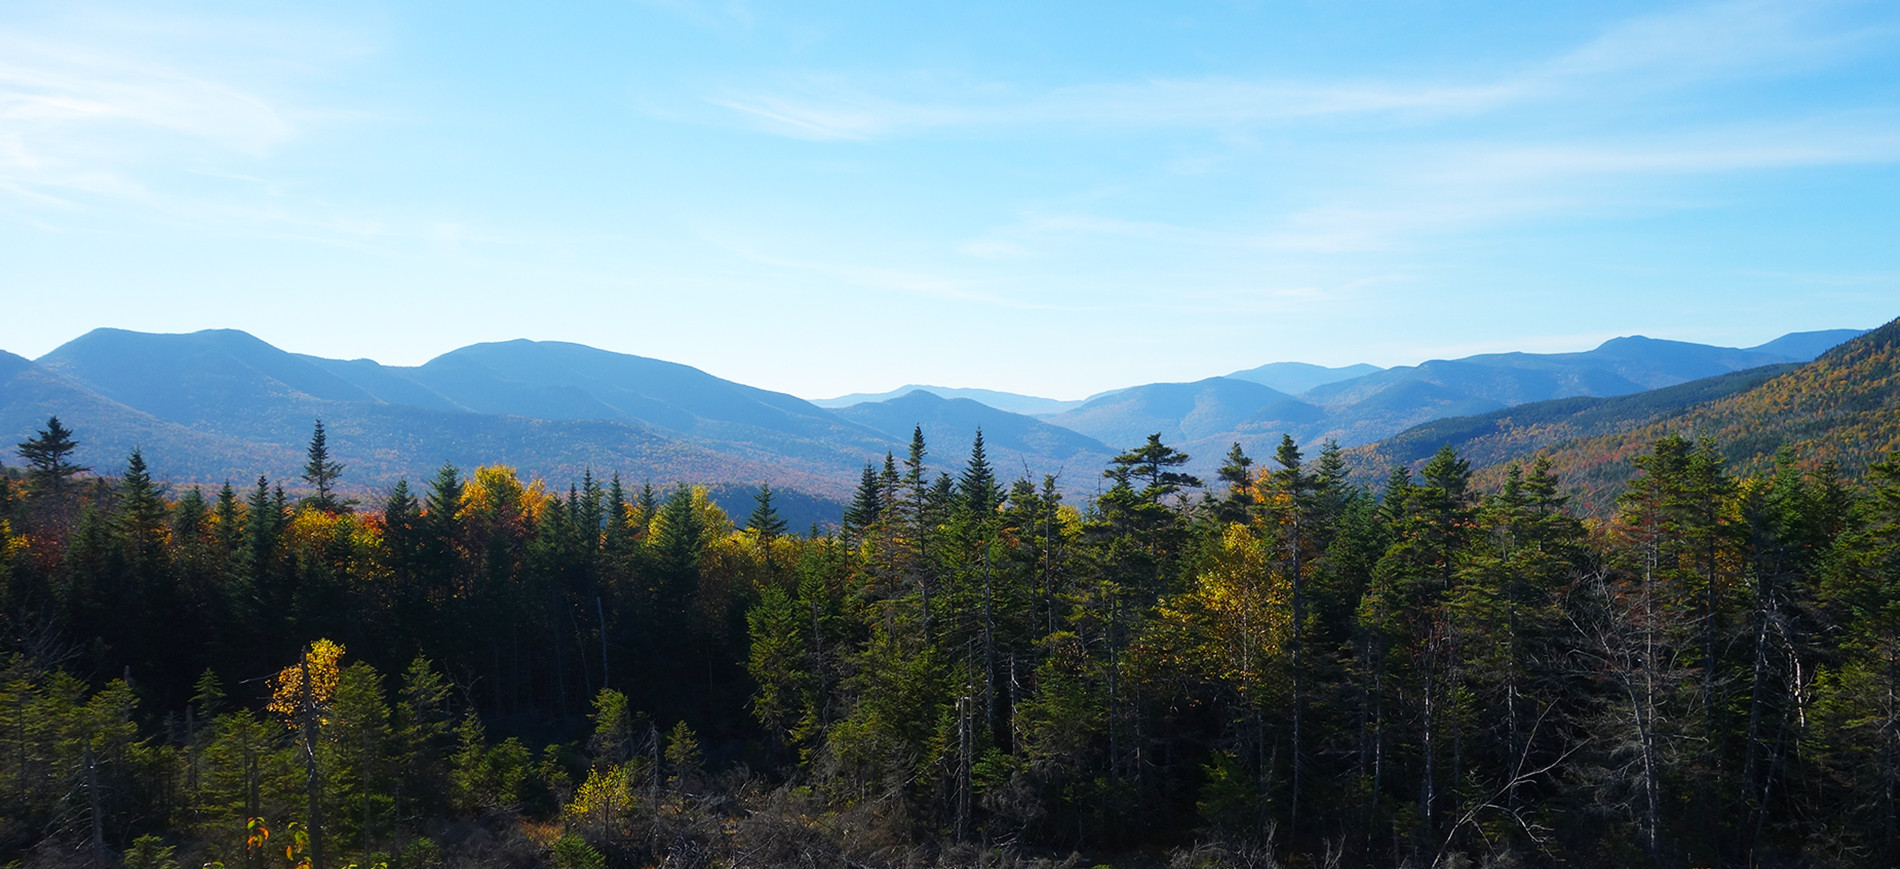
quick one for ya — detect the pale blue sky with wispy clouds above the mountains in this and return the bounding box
[0,0,1900,397]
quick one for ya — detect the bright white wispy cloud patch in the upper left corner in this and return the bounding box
[0,13,545,253]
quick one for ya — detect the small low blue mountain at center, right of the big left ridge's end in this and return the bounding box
[834,390,1119,479]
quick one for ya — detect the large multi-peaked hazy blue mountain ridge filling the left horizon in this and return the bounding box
[11,329,891,494]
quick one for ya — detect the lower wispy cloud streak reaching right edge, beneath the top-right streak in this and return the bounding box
[960,112,1900,261]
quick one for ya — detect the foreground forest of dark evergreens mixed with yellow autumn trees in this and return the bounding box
[0,420,1900,869]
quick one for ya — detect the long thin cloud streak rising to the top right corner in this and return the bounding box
[705,0,1896,141]
